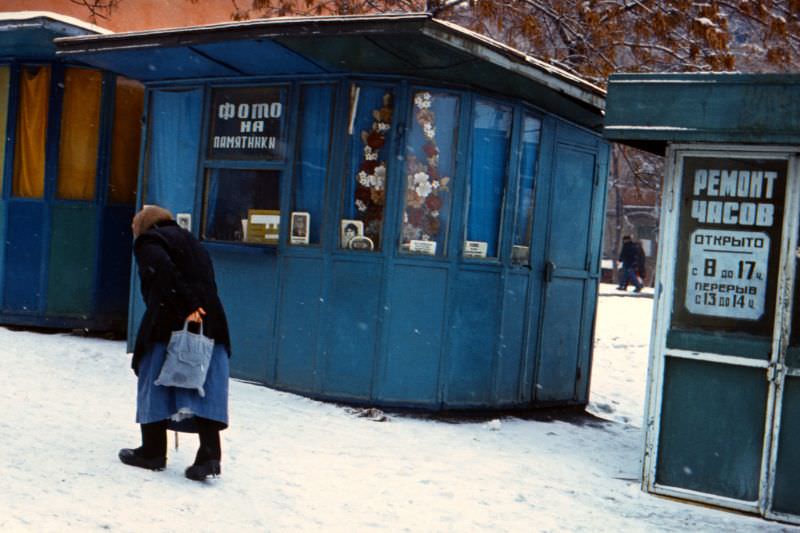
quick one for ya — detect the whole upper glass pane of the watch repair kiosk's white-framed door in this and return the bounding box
[667,157,787,359]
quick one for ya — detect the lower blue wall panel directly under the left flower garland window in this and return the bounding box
[323,260,382,398]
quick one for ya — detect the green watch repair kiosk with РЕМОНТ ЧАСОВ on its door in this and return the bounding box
[605,74,800,523]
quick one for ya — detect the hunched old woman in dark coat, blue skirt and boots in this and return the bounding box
[119,205,230,481]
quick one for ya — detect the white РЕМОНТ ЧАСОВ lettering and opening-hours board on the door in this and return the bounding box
[678,157,786,321]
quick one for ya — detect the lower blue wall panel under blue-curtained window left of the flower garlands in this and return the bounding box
[275,257,324,392]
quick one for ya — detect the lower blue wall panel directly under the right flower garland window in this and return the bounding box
[378,265,448,405]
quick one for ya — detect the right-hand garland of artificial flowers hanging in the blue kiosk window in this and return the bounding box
[401,91,450,246]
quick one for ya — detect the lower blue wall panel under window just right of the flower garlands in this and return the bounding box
[444,270,501,407]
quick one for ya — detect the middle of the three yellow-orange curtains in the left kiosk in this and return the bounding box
[56,68,103,200]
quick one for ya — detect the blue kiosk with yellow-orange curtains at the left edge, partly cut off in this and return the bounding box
[0,12,144,332]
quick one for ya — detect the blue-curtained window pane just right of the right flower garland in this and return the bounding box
[464,100,512,257]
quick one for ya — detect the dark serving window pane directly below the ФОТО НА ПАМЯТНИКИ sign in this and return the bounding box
[203,169,281,244]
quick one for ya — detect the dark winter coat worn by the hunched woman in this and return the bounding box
[131,220,230,373]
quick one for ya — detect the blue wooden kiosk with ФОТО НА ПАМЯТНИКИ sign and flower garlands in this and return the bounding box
[57,14,608,410]
